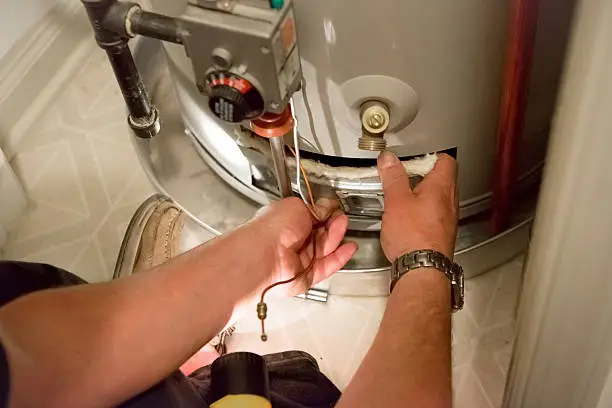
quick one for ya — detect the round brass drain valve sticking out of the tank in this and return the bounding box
[359,101,390,152]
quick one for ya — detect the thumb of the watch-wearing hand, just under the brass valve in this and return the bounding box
[378,151,412,208]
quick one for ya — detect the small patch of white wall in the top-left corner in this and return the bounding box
[0,0,57,59]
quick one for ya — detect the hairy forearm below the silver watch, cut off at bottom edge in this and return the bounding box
[338,269,452,408]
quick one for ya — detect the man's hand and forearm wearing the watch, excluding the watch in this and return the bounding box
[337,152,457,408]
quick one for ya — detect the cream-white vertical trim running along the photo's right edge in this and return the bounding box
[504,0,612,408]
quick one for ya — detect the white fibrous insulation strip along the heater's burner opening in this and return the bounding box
[287,154,438,180]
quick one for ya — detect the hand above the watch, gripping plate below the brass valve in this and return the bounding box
[378,152,459,262]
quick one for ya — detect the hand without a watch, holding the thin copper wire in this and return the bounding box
[252,197,357,296]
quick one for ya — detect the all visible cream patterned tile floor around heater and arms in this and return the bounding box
[3,47,522,408]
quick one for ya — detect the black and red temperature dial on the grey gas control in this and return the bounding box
[206,72,264,123]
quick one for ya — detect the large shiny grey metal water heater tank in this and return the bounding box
[137,0,573,275]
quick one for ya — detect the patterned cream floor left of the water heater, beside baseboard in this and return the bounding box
[4,49,153,282]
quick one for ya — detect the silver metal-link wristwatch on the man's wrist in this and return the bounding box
[391,249,465,312]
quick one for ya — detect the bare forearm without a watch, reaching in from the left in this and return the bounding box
[0,226,275,407]
